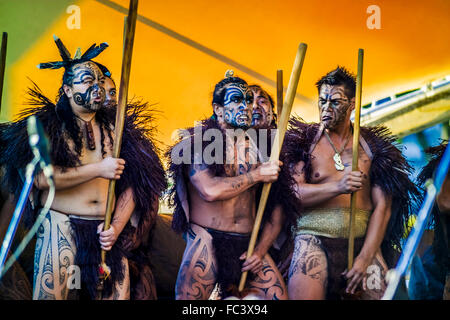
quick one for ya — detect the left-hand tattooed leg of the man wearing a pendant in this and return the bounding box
[288,235,328,300]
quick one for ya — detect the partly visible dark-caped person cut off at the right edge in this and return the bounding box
[408,141,450,300]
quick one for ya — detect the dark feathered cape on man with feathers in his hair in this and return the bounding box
[0,86,166,239]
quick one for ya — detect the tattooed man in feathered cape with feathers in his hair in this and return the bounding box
[0,37,165,299]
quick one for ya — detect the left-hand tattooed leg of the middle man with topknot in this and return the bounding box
[175,224,217,300]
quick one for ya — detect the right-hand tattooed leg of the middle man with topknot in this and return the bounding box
[248,254,288,300]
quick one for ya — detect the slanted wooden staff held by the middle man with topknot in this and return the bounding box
[239,43,307,292]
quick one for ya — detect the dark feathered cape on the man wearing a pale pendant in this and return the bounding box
[281,117,420,264]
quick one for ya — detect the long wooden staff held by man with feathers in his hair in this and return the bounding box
[100,0,138,278]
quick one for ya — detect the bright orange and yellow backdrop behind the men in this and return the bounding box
[0,0,450,151]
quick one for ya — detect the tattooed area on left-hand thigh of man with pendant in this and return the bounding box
[288,235,328,288]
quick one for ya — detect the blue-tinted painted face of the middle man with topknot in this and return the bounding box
[223,83,253,129]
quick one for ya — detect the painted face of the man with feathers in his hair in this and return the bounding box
[69,61,105,111]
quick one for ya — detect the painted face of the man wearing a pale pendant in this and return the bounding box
[319,84,353,129]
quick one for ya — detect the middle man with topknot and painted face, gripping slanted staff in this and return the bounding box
[167,72,287,300]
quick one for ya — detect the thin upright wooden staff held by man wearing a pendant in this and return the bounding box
[347,49,364,271]
